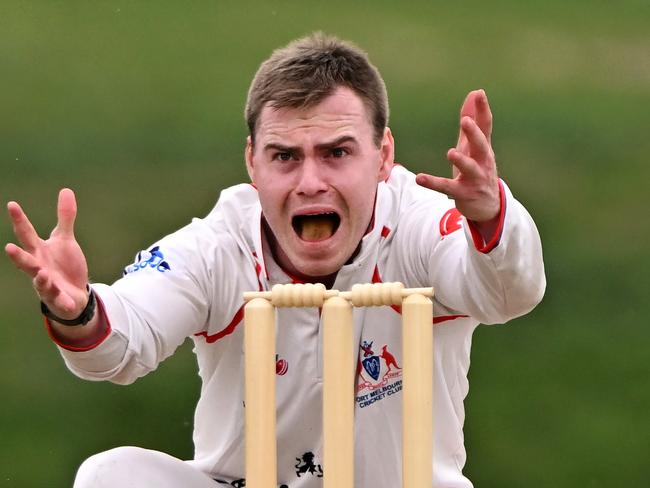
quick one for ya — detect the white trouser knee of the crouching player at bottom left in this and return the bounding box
[73,447,219,488]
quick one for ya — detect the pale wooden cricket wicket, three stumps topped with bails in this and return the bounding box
[244,283,433,488]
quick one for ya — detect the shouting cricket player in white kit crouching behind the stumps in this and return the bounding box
[6,33,545,488]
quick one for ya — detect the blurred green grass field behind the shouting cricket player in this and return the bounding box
[0,0,650,488]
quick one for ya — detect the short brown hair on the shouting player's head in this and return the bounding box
[244,32,388,146]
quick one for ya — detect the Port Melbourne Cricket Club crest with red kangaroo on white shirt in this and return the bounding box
[356,340,402,408]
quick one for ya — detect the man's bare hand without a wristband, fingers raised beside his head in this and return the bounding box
[416,90,500,227]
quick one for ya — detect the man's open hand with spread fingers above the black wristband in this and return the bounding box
[5,189,88,319]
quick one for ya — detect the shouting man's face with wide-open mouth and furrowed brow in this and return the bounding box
[246,87,394,278]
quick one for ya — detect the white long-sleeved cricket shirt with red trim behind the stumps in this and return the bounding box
[55,166,545,488]
